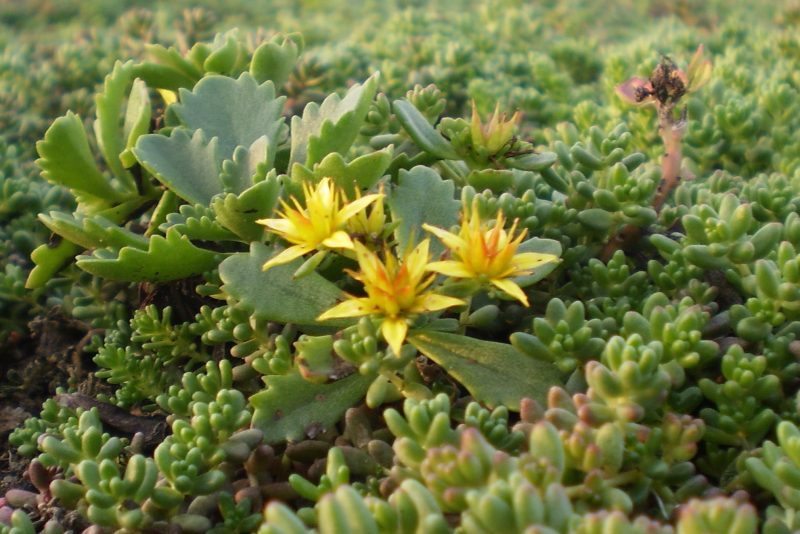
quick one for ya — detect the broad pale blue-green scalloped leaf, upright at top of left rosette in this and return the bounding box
[173,73,286,164]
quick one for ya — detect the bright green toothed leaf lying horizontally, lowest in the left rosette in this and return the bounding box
[76,229,218,283]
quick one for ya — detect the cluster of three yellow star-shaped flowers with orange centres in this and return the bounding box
[259,178,558,354]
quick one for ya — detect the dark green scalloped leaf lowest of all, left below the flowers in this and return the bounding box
[250,371,374,443]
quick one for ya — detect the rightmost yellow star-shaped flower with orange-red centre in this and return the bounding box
[422,204,558,306]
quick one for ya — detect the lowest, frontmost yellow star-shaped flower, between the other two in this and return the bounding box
[317,239,464,354]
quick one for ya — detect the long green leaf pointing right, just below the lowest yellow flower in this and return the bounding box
[408,331,563,411]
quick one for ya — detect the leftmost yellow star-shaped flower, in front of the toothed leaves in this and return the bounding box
[256,178,383,271]
